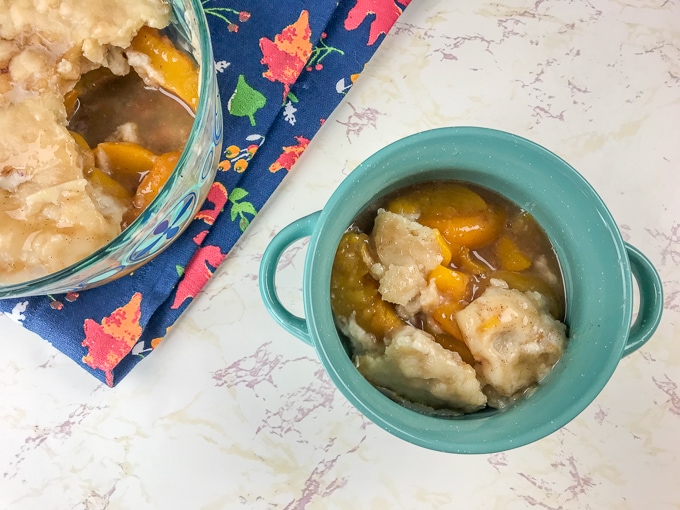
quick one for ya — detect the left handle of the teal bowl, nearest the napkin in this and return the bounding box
[259,211,321,345]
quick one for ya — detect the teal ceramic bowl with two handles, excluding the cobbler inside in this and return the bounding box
[260,127,663,453]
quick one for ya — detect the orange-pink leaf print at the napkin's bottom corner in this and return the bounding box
[82,292,142,386]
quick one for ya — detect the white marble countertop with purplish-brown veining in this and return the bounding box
[0,0,680,510]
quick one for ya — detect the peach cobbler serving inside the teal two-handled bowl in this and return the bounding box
[331,181,567,413]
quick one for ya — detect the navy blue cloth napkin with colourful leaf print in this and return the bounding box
[0,0,410,386]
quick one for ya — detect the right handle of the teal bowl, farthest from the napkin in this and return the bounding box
[623,243,663,356]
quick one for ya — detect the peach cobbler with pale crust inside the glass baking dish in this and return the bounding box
[0,0,198,285]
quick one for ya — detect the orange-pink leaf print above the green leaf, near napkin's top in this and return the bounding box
[260,11,312,100]
